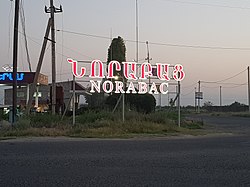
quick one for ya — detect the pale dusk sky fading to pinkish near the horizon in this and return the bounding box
[0,0,250,106]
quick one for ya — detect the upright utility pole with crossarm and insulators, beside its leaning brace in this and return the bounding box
[45,0,62,115]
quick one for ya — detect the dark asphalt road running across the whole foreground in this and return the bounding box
[0,116,250,187]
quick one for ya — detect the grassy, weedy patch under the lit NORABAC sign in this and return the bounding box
[0,111,202,138]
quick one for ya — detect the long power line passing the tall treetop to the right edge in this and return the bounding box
[57,30,250,51]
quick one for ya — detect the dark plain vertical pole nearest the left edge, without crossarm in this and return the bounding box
[12,0,20,125]
